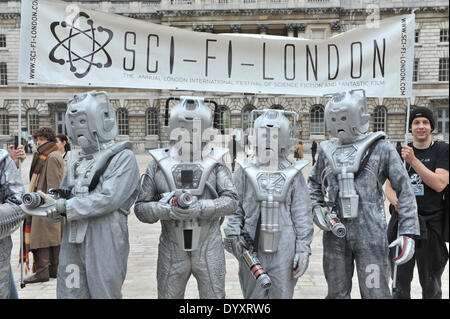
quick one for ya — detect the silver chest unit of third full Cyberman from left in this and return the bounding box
[242,160,308,253]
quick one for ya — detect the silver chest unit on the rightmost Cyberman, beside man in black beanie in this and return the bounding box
[320,132,386,218]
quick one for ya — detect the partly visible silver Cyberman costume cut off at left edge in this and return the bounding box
[0,149,25,299]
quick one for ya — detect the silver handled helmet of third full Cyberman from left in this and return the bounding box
[249,109,298,158]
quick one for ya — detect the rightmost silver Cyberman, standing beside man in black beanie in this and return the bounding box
[308,90,419,298]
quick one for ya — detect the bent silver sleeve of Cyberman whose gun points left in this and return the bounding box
[66,149,139,221]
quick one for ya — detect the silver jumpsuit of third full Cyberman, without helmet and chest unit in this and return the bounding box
[224,161,313,299]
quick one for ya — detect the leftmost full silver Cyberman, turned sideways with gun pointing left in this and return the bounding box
[21,91,139,299]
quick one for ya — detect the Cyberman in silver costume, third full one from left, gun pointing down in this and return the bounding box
[224,110,313,299]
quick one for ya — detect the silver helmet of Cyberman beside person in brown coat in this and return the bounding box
[66,91,117,152]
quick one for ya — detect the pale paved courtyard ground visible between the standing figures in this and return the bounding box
[8,154,449,299]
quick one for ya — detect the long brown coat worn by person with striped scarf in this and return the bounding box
[30,151,65,249]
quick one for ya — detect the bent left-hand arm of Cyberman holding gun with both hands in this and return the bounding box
[134,161,171,224]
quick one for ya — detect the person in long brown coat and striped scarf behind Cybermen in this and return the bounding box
[25,127,65,283]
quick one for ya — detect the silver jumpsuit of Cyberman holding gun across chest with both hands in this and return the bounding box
[134,156,238,299]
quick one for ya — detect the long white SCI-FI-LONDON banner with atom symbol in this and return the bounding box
[19,0,414,97]
